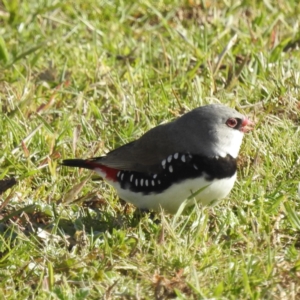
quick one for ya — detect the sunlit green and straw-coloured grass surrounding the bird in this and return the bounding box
[0,0,300,299]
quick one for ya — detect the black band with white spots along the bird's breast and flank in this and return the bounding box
[117,153,237,195]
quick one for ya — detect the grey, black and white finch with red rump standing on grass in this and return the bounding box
[61,104,254,214]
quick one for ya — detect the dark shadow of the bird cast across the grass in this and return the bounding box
[0,193,158,254]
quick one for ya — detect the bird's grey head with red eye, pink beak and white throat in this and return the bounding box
[173,104,253,158]
